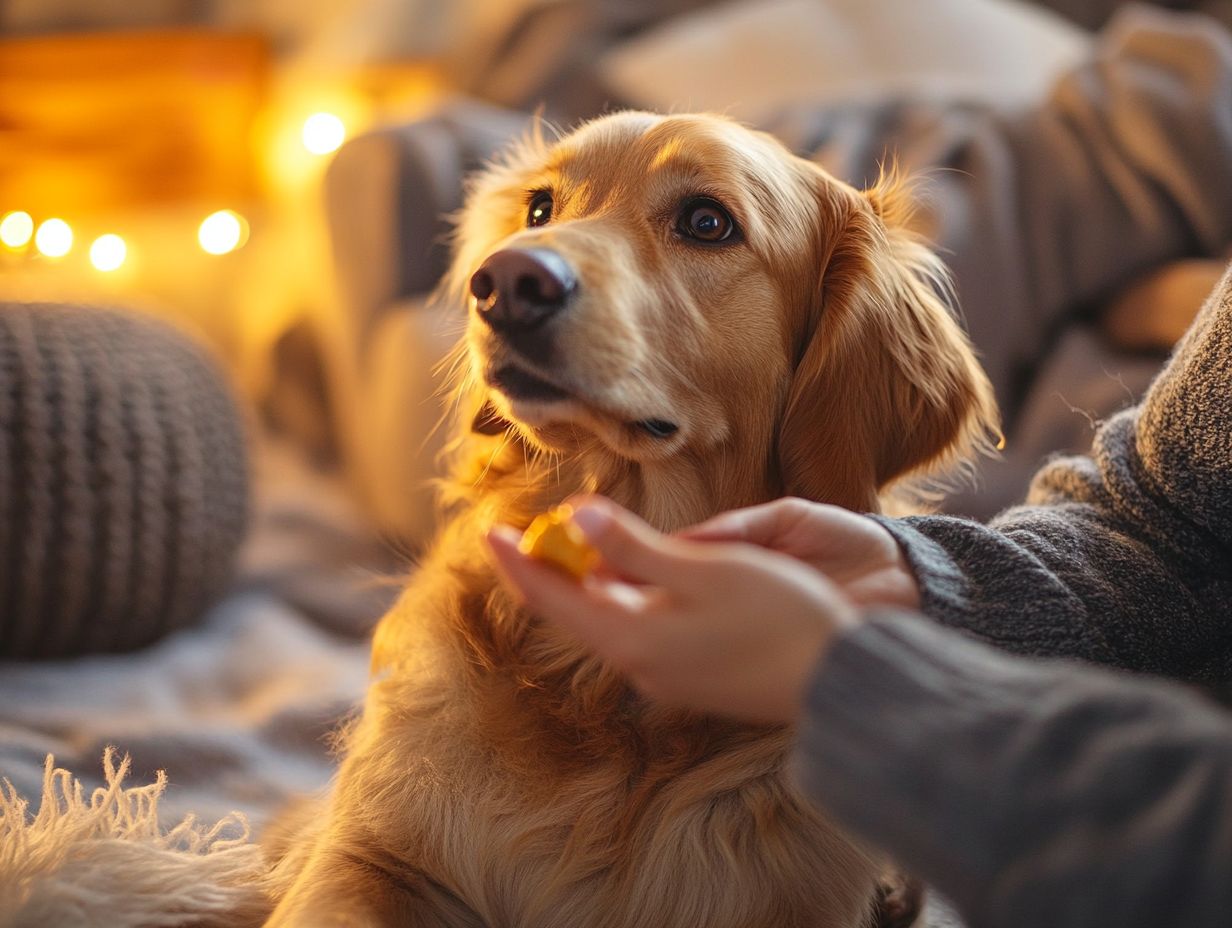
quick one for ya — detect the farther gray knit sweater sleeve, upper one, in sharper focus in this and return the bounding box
[878,272,1232,682]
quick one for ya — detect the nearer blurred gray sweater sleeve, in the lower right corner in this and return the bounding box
[793,613,1232,928]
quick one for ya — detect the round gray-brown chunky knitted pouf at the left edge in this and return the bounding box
[0,303,248,659]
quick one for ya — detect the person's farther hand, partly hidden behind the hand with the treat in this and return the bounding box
[680,498,920,609]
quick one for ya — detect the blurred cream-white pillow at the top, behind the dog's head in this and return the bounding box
[600,0,1092,123]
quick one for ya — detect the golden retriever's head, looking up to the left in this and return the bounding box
[455,112,995,509]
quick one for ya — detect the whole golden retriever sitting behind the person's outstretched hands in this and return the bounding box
[269,112,995,928]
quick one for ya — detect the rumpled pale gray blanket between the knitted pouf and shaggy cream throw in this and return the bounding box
[0,444,395,826]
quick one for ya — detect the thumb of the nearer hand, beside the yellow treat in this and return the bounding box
[570,497,691,588]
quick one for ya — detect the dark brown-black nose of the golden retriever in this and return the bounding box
[471,248,578,335]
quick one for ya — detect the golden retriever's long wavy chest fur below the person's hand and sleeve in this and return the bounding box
[334,507,876,928]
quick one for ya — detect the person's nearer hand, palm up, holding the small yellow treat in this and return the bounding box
[488,497,857,723]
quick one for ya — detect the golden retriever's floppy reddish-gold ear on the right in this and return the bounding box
[779,169,998,510]
